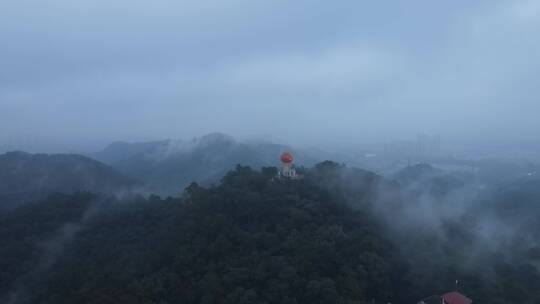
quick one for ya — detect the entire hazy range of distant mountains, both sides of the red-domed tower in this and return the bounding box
[0,133,534,207]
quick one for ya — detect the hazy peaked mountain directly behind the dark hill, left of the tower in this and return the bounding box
[95,133,321,195]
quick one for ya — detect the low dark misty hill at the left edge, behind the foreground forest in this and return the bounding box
[0,152,137,208]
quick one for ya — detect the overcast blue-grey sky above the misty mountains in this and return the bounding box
[0,0,540,149]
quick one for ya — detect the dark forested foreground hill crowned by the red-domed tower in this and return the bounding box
[0,164,400,304]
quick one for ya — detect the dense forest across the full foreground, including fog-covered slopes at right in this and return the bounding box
[0,162,540,304]
